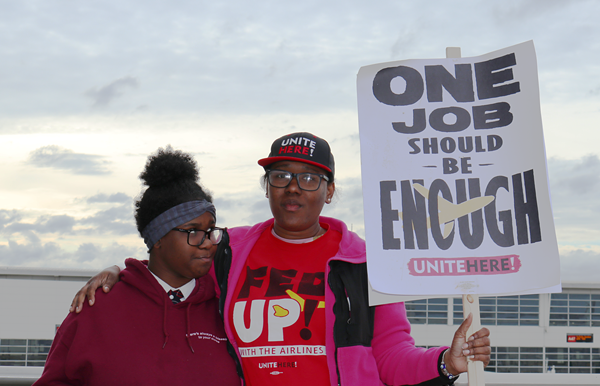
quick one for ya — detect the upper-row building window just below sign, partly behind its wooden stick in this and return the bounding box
[453,295,540,326]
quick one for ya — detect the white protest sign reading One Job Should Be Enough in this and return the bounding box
[357,42,560,295]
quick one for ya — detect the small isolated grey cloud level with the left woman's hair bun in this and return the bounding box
[26,145,111,175]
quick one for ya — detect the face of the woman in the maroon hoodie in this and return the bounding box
[148,212,217,288]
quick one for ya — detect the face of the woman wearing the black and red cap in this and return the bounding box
[267,161,335,239]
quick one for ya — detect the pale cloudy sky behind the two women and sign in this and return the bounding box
[0,0,600,282]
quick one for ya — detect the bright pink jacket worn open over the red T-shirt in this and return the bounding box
[223,217,453,386]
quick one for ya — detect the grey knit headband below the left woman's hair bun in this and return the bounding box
[142,200,217,250]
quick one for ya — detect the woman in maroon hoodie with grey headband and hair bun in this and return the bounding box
[35,147,241,386]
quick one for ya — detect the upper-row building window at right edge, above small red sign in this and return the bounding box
[550,293,600,327]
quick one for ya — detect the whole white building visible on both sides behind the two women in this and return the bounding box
[0,267,600,386]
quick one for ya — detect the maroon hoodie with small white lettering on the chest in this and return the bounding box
[35,259,241,386]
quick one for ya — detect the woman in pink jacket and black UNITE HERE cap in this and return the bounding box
[72,133,490,385]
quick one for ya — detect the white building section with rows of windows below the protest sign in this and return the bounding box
[406,283,600,385]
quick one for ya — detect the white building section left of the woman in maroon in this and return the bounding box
[0,267,97,385]
